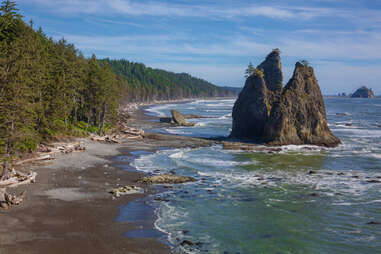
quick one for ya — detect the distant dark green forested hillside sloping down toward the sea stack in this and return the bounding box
[99,59,235,102]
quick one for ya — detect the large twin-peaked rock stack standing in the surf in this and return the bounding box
[230,50,341,147]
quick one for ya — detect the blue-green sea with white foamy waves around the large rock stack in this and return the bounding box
[133,98,381,254]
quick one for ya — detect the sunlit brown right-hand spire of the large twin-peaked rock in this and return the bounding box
[264,62,341,147]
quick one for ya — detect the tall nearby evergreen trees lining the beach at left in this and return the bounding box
[0,1,121,155]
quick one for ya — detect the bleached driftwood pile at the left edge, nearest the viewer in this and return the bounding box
[0,162,37,209]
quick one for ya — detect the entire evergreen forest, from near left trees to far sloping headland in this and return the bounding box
[0,0,234,160]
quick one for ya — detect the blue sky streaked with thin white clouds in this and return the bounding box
[15,0,381,95]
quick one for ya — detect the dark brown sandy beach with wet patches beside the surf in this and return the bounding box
[0,106,213,254]
